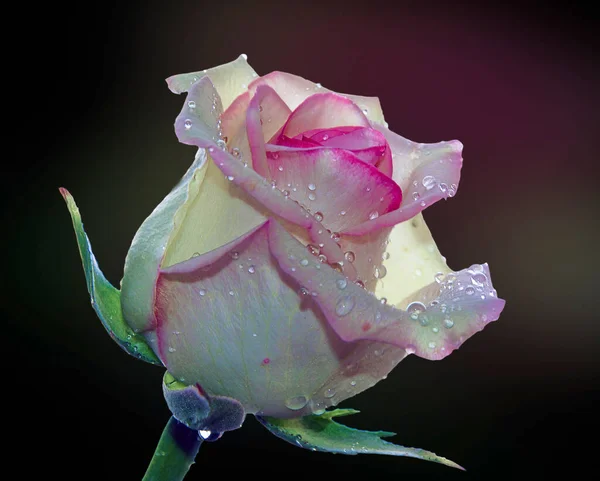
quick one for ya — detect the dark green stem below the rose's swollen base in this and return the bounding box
[142,416,203,481]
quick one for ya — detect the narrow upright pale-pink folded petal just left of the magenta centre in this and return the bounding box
[246,85,291,177]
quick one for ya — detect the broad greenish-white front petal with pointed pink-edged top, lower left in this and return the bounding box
[154,223,353,417]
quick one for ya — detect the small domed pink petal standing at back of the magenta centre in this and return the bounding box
[281,93,370,137]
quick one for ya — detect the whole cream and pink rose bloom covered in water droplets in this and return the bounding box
[116,56,504,418]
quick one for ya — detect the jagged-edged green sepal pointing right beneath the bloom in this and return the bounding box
[257,409,464,470]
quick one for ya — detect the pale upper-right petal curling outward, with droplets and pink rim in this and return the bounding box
[344,125,462,235]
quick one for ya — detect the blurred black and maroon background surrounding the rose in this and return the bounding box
[0,1,600,480]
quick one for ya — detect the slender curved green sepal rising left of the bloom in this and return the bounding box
[60,188,162,366]
